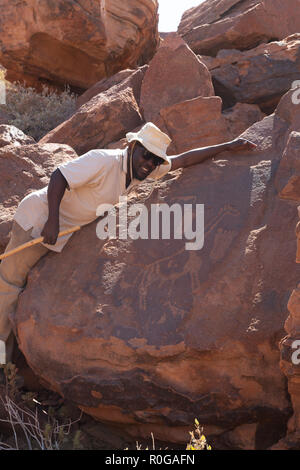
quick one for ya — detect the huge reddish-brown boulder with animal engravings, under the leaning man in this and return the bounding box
[11,91,300,449]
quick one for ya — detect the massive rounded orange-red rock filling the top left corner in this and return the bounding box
[0,0,159,92]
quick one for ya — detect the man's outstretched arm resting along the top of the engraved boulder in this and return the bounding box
[170,139,257,171]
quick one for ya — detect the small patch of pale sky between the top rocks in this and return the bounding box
[158,0,204,33]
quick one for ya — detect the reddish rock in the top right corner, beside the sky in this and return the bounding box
[178,0,300,56]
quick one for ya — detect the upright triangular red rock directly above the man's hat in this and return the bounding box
[140,33,214,121]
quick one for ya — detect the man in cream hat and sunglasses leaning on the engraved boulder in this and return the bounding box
[0,123,256,364]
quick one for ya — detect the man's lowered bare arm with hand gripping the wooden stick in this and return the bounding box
[41,169,68,245]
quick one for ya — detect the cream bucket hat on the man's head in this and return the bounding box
[126,122,172,163]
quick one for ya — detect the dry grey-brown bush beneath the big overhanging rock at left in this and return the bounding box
[0,68,77,141]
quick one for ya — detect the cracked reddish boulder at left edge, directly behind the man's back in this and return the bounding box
[0,143,78,252]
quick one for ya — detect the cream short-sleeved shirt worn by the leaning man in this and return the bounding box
[14,149,171,252]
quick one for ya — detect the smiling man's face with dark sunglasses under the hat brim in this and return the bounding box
[132,142,164,181]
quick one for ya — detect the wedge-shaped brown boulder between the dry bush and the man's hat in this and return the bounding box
[40,85,142,155]
